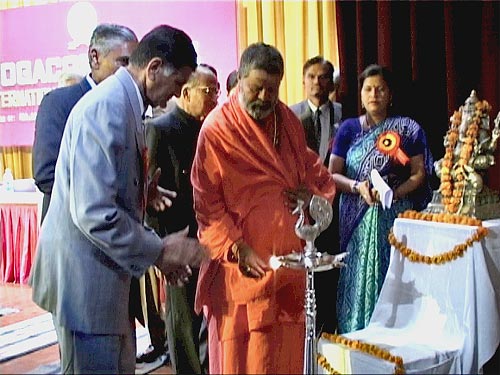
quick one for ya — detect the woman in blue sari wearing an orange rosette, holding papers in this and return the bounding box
[329,65,432,333]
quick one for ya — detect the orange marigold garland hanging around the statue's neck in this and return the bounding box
[439,100,491,214]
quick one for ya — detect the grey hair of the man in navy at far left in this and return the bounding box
[89,23,138,63]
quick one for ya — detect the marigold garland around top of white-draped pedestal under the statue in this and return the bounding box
[389,210,488,264]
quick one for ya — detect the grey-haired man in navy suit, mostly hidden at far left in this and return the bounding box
[32,24,138,221]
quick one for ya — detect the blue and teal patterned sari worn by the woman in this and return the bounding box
[333,117,432,333]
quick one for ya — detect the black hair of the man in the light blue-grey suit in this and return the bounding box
[130,25,197,70]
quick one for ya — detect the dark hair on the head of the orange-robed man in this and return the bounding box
[238,43,285,78]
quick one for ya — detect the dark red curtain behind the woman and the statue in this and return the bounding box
[336,1,500,190]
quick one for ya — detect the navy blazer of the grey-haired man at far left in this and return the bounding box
[32,78,91,220]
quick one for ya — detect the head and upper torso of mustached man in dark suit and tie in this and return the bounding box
[290,56,342,166]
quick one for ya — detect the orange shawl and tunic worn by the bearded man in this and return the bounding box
[191,92,335,336]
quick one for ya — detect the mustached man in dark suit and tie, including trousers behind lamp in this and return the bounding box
[290,56,342,333]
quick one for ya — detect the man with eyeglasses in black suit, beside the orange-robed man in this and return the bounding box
[147,64,219,374]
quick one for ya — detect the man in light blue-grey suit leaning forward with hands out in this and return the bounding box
[30,25,207,374]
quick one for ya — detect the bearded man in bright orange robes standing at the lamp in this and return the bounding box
[191,43,335,374]
